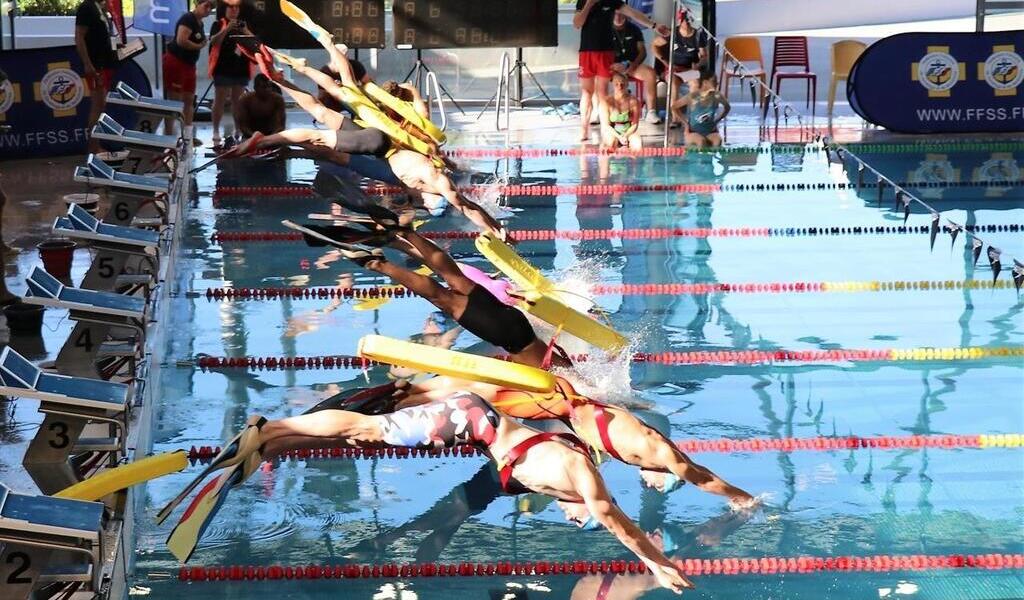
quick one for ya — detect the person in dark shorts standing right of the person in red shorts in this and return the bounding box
[209,0,253,147]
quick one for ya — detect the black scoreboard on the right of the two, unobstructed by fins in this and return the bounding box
[392,0,558,48]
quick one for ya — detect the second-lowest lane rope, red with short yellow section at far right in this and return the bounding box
[188,433,1024,461]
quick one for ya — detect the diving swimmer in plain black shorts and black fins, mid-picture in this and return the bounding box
[285,206,571,368]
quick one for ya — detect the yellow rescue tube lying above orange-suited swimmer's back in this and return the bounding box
[358,336,555,393]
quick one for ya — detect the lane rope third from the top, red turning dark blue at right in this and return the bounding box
[210,223,1024,244]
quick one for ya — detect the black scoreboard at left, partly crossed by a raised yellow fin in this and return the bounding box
[243,0,384,49]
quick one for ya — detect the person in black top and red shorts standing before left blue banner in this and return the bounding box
[75,0,118,153]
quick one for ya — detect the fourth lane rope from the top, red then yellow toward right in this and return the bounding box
[206,280,1014,301]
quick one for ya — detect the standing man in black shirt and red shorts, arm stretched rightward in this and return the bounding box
[572,0,671,141]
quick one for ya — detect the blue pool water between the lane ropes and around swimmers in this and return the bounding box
[135,144,1024,600]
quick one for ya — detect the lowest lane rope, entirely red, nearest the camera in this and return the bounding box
[178,554,1024,583]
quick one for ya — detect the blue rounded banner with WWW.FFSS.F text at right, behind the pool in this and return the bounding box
[847,31,1024,133]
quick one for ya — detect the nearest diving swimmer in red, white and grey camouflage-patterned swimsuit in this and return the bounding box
[158,392,693,593]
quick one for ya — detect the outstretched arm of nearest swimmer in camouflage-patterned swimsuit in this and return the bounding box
[565,456,693,594]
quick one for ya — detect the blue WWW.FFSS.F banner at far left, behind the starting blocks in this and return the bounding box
[0,46,153,160]
